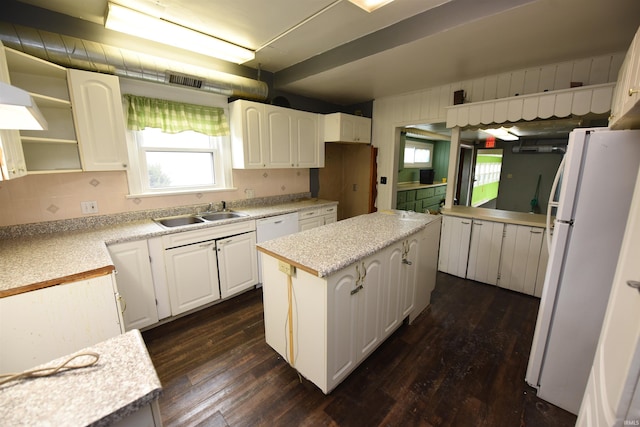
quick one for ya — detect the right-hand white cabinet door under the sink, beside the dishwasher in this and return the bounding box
[216,231,258,298]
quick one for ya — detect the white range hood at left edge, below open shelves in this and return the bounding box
[0,82,47,130]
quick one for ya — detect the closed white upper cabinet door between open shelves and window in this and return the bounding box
[67,70,127,171]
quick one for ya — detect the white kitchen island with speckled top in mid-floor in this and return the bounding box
[258,211,441,393]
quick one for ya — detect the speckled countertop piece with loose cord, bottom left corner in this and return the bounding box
[0,330,162,426]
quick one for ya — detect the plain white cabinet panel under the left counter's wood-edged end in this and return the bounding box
[0,274,124,373]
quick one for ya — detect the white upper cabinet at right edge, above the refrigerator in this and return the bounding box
[609,24,640,129]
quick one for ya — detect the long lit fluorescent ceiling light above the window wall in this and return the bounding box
[104,2,255,64]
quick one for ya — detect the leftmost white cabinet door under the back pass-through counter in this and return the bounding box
[438,216,472,278]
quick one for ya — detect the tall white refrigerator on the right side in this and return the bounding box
[526,128,640,414]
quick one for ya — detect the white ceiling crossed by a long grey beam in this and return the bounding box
[8,0,640,105]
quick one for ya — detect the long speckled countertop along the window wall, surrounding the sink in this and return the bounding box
[0,199,337,298]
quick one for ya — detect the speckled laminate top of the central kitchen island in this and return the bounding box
[258,210,437,277]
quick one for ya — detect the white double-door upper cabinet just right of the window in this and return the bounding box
[229,100,324,169]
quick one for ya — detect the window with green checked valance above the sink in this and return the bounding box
[125,95,232,195]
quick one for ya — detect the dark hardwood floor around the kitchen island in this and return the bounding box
[143,273,576,427]
